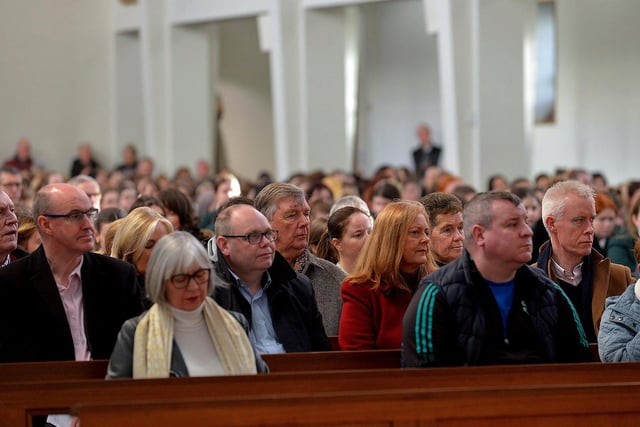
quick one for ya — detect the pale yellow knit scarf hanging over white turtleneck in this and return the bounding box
[133,297,256,378]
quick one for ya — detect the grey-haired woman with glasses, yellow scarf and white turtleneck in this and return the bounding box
[107,231,267,378]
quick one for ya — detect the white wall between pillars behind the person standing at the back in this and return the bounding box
[358,0,441,175]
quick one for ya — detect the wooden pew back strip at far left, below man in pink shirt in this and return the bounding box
[0,360,109,384]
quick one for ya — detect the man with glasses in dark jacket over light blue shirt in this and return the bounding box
[210,204,330,354]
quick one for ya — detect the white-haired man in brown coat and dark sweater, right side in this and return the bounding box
[534,181,634,342]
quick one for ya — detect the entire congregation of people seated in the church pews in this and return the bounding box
[0,141,640,386]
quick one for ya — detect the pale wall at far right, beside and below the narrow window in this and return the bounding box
[532,0,640,184]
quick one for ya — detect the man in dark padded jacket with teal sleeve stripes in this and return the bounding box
[402,191,592,367]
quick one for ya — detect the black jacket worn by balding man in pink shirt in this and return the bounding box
[0,245,142,362]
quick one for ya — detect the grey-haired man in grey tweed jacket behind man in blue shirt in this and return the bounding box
[254,182,346,336]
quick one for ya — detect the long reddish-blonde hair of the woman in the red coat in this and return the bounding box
[347,200,437,292]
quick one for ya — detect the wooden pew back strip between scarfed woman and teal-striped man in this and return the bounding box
[262,349,400,372]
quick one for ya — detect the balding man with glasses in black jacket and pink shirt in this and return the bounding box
[0,184,142,362]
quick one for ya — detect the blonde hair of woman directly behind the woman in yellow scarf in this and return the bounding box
[109,207,173,264]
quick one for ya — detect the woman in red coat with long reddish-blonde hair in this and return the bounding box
[338,201,436,350]
